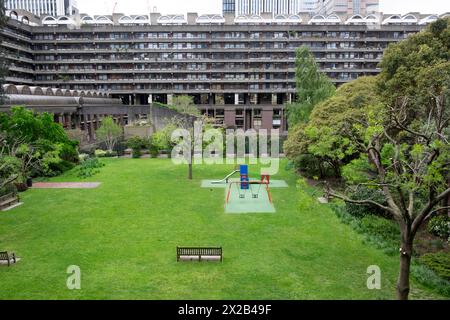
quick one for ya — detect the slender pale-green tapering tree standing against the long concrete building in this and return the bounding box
[287,46,335,127]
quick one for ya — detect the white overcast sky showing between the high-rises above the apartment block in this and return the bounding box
[77,0,450,14]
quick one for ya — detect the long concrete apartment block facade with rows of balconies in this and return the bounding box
[0,12,438,131]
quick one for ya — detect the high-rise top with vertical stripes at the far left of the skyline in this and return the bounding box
[5,0,77,16]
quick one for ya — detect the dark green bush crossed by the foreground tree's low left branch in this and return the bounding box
[345,187,387,217]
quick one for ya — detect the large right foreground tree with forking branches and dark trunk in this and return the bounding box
[327,20,450,300]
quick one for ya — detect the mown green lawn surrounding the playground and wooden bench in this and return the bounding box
[0,159,442,299]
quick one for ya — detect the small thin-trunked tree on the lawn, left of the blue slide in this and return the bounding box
[172,96,202,180]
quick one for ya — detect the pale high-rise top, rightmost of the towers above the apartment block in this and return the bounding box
[319,0,380,15]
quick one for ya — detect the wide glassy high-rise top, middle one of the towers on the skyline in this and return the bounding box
[222,0,322,16]
